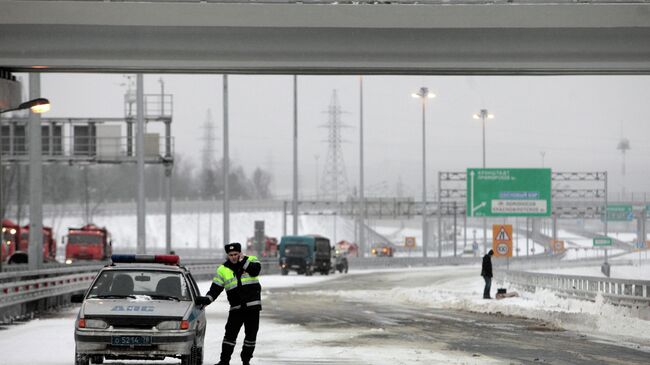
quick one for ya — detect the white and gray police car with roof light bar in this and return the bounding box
[72,255,210,365]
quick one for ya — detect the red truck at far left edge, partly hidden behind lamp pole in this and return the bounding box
[3,220,56,264]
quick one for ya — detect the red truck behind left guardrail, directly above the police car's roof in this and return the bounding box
[65,224,112,264]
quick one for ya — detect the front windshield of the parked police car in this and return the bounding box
[88,269,191,301]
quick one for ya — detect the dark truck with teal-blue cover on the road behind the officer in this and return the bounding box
[279,235,332,276]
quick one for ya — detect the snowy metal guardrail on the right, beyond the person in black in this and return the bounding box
[496,270,650,309]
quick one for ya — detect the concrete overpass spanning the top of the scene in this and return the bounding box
[0,0,650,74]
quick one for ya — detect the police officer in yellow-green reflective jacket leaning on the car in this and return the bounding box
[206,242,262,365]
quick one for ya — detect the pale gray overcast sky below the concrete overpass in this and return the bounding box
[25,74,650,197]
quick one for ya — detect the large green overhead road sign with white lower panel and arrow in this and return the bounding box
[467,168,551,217]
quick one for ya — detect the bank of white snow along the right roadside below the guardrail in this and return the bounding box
[304,266,650,351]
